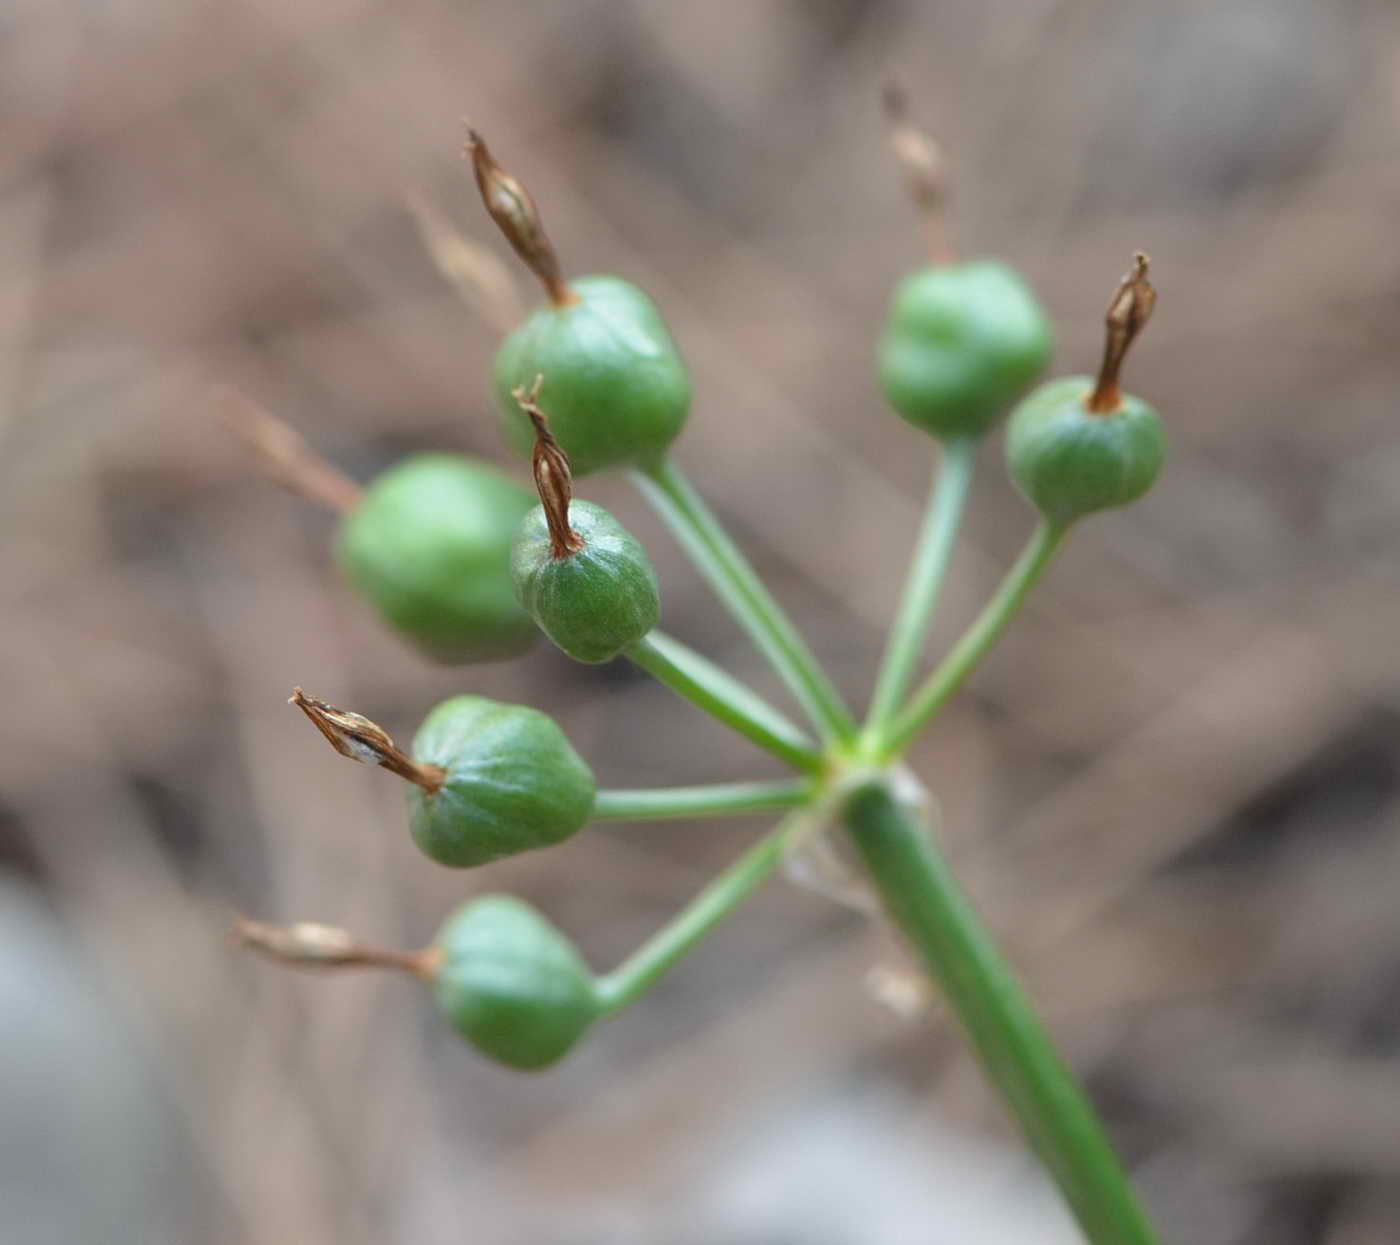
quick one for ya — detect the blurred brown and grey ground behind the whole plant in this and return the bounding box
[0,0,1400,1245]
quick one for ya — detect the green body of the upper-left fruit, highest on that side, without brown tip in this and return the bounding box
[496,276,690,476]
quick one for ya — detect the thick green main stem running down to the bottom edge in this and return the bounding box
[846,783,1156,1245]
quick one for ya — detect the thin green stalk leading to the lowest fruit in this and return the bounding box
[596,808,816,1015]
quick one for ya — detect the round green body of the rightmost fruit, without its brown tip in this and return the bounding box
[1007,377,1166,524]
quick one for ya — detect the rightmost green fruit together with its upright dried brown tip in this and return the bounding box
[1007,252,1166,527]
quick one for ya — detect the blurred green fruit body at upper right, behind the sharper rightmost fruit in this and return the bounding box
[879,259,1054,440]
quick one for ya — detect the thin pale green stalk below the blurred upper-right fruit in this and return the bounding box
[865,437,977,735]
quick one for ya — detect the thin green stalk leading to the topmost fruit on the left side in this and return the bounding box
[633,459,855,742]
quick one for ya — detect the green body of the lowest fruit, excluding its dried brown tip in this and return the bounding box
[437,895,598,1069]
